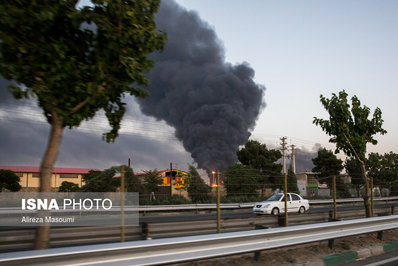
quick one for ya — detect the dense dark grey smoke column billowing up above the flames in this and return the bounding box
[139,1,265,170]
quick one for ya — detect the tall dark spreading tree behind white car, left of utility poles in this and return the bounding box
[236,140,283,195]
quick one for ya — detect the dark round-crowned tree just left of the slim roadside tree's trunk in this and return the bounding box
[312,148,349,197]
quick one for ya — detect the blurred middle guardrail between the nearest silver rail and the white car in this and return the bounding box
[0,206,394,252]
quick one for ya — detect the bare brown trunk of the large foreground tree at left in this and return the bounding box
[34,113,64,249]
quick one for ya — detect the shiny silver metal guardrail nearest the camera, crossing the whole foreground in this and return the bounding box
[0,215,398,265]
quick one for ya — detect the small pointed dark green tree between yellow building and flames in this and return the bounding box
[185,165,211,203]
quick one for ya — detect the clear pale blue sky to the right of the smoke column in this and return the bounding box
[177,0,398,153]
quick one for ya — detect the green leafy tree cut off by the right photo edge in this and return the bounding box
[367,152,398,195]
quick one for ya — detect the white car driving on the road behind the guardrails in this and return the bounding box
[253,193,310,215]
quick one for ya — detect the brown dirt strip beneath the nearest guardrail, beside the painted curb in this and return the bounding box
[179,230,398,266]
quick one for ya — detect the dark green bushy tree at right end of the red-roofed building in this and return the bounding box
[82,167,120,192]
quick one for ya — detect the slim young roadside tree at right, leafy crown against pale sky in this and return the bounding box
[313,90,387,217]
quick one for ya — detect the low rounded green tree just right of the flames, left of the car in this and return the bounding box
[224,164,261,199]
